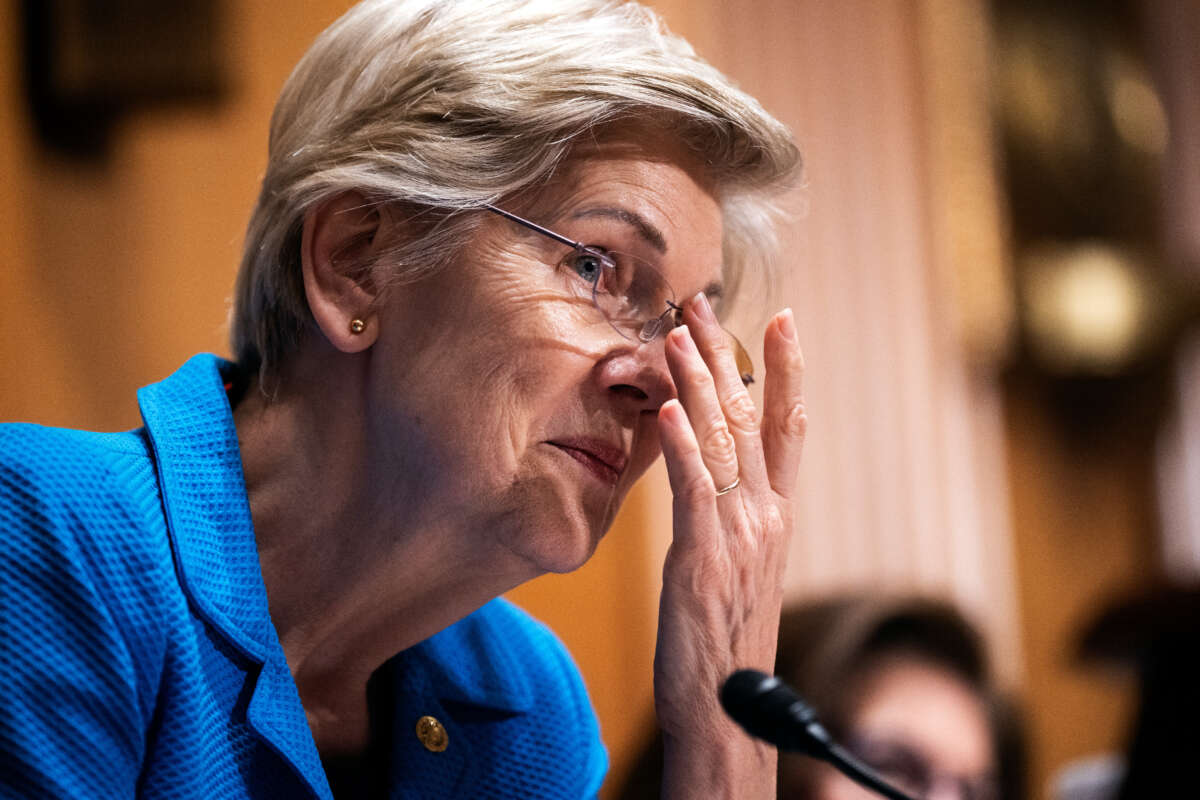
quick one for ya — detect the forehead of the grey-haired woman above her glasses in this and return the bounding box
[534,136,724,294]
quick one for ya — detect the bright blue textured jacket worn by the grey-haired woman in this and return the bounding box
[0,355,607,800]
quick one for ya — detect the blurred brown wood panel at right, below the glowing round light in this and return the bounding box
[1007,377,1159,798]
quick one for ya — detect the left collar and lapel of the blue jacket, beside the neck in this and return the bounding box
[138,355,331,799]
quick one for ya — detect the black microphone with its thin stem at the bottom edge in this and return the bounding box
[721,669,917,800]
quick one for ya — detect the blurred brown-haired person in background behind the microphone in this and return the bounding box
[619,594,1025,800]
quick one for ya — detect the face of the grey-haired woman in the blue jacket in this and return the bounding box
[370,138,722,573]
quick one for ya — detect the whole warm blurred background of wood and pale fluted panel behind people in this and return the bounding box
[0,0,1200,798]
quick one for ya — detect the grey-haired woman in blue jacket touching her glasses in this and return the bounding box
[0,0,805,798]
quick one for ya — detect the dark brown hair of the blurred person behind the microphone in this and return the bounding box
[617,594,1026,800]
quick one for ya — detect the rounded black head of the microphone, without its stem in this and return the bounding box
[721,669,830,758]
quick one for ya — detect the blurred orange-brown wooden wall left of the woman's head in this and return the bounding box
[0,0,346,428]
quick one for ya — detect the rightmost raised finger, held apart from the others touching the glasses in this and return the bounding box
[762,308,808,497]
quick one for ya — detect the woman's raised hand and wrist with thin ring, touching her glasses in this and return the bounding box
[654,295,808,798]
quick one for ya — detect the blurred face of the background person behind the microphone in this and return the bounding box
[814,655,995,800]
